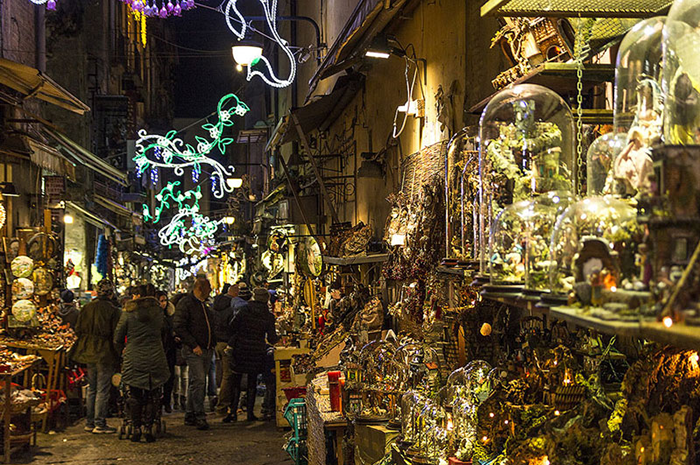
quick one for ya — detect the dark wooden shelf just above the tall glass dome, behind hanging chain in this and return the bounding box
[469,63,615,114]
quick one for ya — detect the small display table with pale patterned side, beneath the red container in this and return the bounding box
[306,377,348,465]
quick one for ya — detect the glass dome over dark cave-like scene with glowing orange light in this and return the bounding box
[549,196,651,319]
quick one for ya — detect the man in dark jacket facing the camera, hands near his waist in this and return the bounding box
[174,277,216,430]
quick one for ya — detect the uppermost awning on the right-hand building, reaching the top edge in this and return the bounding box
[309,0,408,95]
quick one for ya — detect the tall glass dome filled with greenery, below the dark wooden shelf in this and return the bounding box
[479,84,576,272]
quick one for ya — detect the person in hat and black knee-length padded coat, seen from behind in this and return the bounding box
[226,287,278,421]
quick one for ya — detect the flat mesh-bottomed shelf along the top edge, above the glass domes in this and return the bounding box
[481,0,673,18]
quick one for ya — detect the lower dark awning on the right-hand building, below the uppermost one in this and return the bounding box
[265,74,364,150]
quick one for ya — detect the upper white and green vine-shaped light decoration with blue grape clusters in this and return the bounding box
[134,94,250,199]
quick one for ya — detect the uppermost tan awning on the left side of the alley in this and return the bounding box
[0,58,90,115]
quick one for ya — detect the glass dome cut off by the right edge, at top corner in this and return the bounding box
[662,0,700,145]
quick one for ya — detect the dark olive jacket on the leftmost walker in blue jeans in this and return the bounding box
[70,297,122,367]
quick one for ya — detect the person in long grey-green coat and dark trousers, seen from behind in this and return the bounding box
[114,284,170,442]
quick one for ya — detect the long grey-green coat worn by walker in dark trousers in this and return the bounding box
[114,297,170,391]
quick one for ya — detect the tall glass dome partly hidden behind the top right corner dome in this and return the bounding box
[614,16,666,138]
